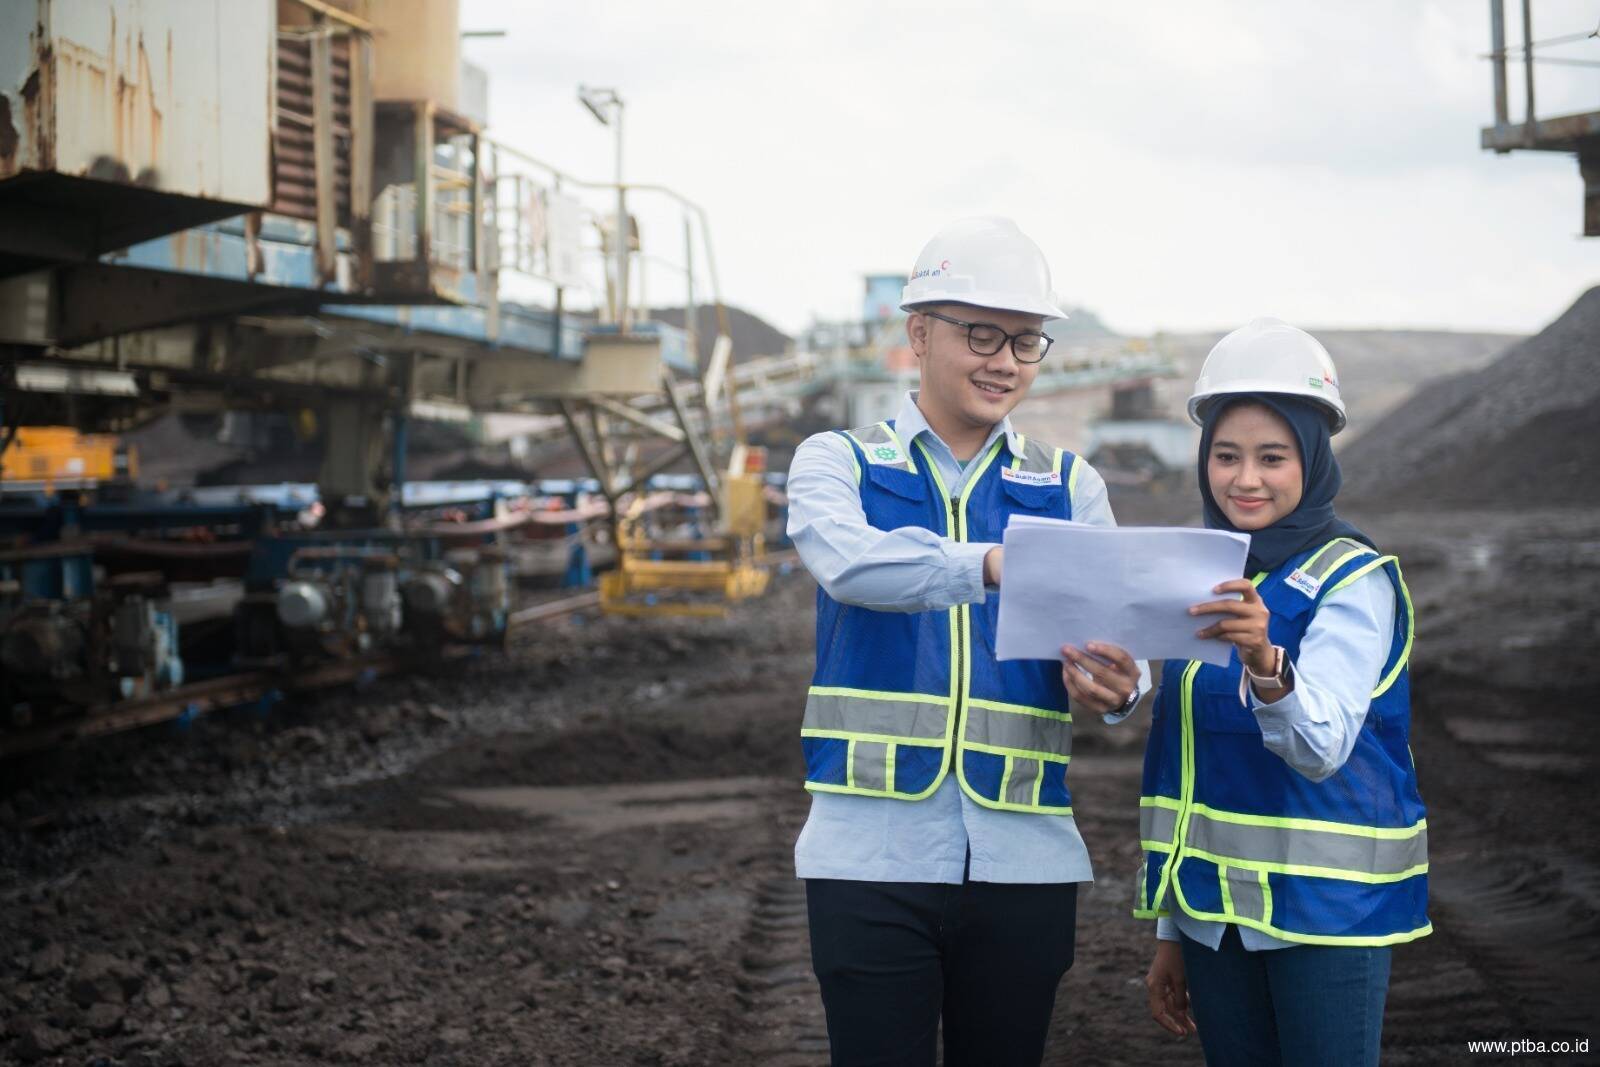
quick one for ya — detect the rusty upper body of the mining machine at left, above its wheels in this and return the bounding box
[0,0,736,522]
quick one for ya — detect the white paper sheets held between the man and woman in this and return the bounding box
[995,515,1250,665]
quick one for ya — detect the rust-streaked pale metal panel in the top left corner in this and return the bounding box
[0,0,277,206]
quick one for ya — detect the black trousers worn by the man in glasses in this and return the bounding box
[806,878,1078,1067]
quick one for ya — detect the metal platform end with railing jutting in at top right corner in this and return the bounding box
[1482,0,1600,237]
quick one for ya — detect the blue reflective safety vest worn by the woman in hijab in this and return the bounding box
[1134,539,1434,945]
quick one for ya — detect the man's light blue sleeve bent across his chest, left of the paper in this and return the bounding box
[787,434,998,611]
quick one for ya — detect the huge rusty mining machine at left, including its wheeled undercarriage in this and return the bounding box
[0,0,768,742]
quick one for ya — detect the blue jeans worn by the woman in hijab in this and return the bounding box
[1182,926,1390,1067]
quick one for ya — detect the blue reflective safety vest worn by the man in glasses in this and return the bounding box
[800,422,1078,814]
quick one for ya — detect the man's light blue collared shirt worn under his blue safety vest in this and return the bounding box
[789,392,1150,883]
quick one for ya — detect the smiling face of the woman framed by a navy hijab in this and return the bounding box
[1206,402,1304,530]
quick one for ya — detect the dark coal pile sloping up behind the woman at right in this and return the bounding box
[1341,286,1600,507]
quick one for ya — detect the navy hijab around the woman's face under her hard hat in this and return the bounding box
[1200,394,1378,576]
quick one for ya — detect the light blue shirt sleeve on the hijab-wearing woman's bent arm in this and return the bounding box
[1245,568,1395,782]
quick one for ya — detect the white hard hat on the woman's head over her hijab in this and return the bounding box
[1189,318,1344,434]
